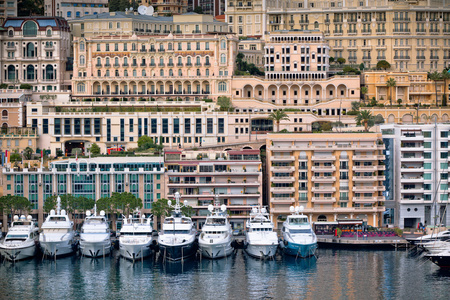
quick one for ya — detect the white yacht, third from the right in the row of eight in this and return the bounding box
[198,205,233,258]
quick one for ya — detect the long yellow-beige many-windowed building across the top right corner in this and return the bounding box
[226,0,450,71]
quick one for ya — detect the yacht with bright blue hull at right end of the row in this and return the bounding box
[280,206,317,257]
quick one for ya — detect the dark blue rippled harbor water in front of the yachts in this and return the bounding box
[0,249,450,300]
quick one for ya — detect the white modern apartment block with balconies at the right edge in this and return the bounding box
[380,123,450,228]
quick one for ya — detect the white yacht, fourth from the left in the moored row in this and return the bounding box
[119,215,153,262]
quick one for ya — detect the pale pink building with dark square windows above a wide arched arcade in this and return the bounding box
[232,31,360,115]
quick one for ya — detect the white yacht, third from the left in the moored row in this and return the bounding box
[80,207,111,257]
